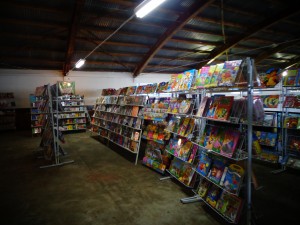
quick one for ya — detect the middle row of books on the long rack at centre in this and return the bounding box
[92,111,142,129]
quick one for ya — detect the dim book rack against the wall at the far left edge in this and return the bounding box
[0,92,16,131]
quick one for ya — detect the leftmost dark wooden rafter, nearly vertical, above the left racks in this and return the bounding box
[63,0,85,76]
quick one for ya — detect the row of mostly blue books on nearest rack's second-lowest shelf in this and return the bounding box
[196,151,245,194]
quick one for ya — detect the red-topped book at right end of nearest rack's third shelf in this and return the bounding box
[220,129,240,158]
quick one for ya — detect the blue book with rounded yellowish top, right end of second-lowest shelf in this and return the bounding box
[220,164,245,194]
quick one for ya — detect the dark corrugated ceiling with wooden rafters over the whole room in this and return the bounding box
[0,0,300,77]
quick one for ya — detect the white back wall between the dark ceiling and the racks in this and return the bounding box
[0,69,170,108]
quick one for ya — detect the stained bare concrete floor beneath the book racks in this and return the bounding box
[0,131,300,225]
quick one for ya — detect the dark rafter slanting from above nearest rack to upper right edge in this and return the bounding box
[198,6,300,68]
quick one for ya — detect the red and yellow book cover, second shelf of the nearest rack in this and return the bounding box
[214,96,233,120]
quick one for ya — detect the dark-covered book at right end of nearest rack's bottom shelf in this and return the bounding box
[216,191,243,223]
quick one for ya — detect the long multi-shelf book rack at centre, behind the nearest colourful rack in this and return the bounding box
[91,89,146,165]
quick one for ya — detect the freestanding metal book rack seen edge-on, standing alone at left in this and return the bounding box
[36,84,74,168]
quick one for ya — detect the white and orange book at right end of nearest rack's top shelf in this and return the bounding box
[219,60,242,86]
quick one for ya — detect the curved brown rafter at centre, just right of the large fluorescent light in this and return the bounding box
[133,0,214,77]
